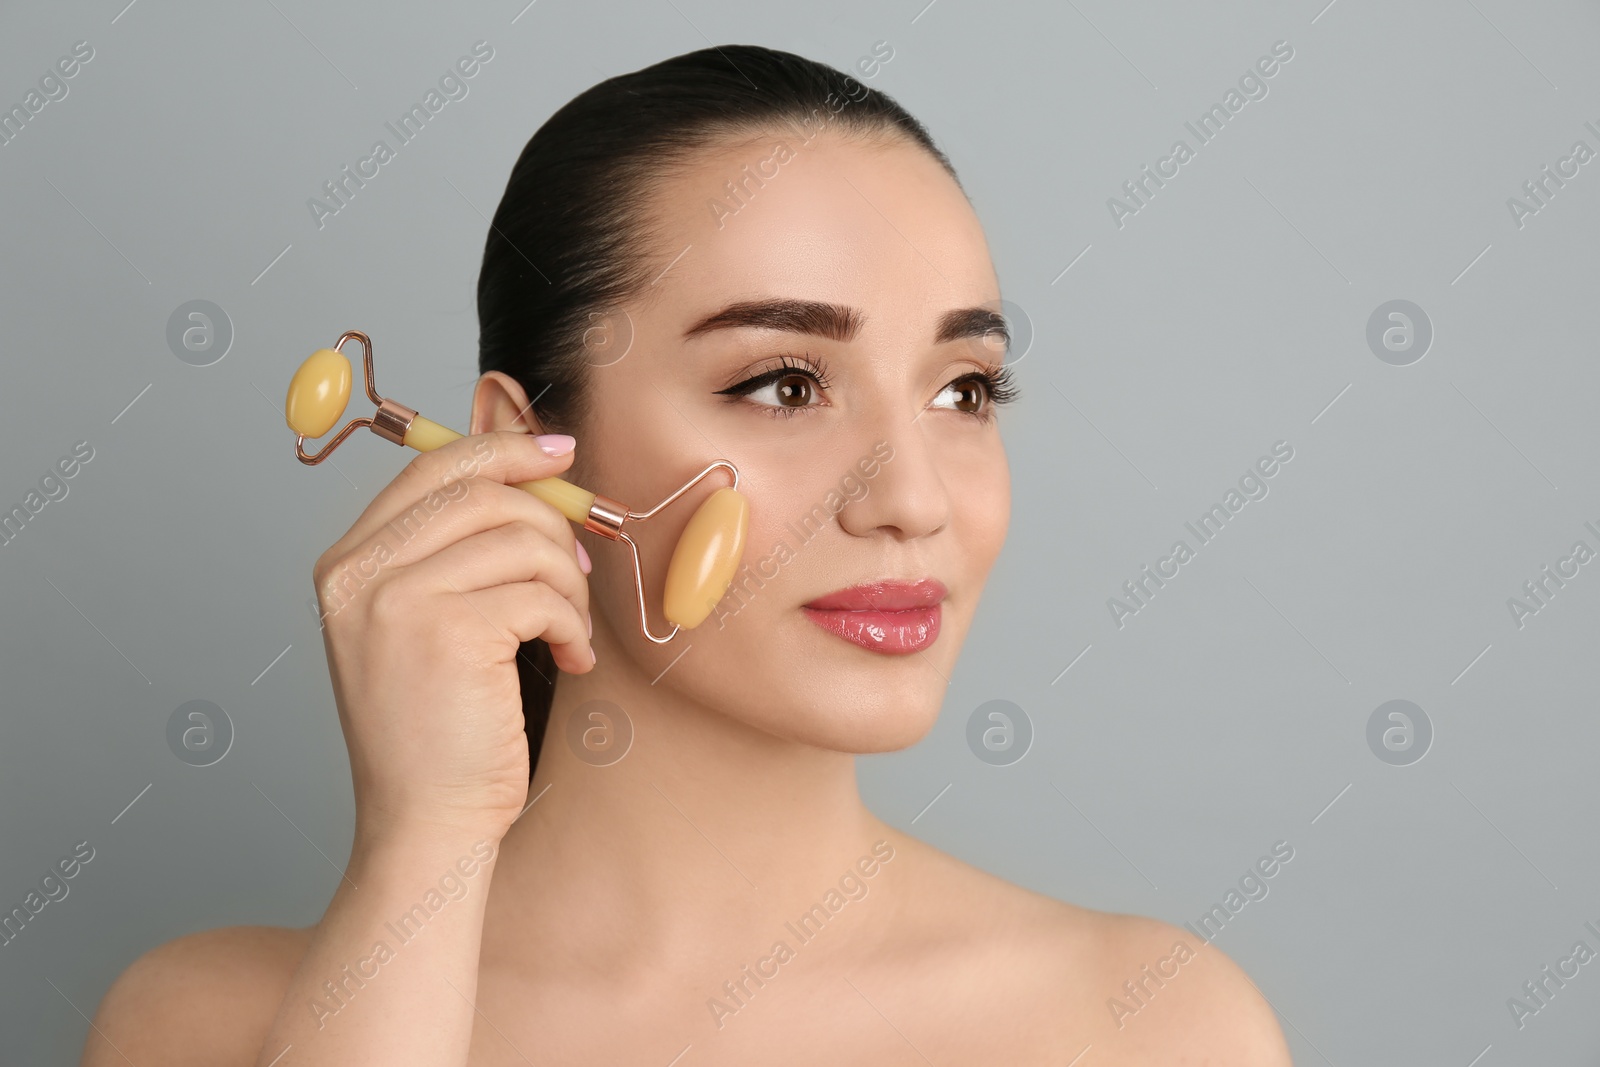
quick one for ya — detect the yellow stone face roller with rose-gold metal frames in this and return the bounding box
[283,330,750,645]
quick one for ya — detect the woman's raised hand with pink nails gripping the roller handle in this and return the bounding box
[312,430,594,841]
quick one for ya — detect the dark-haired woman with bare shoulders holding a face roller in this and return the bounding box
[83,46,1290,1067]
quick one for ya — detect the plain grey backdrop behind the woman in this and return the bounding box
[0,0,1600,1067]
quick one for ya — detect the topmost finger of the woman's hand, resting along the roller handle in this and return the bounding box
[318,430,573,563]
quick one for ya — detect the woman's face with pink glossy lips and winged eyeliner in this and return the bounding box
[486,131,1011,752]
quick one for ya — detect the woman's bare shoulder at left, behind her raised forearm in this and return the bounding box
[82,926,314,1067]
